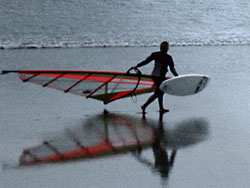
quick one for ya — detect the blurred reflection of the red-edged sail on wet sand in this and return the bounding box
[19,113,154,165]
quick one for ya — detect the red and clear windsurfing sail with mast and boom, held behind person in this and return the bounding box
[2,68,169,104]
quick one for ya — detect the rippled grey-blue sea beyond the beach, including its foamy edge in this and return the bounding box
[0,0,250,49]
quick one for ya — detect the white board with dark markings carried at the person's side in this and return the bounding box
[160,74,210,96]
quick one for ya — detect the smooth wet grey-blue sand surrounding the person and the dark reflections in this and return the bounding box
[0,46,250,188]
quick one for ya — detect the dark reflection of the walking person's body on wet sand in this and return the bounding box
[135,114,177,178]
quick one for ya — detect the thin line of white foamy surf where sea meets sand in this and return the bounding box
[0,39,250,49]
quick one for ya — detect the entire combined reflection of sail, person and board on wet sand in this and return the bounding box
[19,112,209,181]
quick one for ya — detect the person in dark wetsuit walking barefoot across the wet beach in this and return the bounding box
[133,41,178,113]
